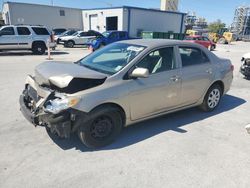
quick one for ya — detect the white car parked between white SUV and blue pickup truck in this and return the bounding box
[61,30,101,48]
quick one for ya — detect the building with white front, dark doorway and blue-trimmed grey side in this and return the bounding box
[82,6,186,37]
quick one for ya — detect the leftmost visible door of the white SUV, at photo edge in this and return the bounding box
[0,27,18,50]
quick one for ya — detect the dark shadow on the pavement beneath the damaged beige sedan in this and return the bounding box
[49,95,246,152]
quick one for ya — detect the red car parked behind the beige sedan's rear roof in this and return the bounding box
[184,35,216,51]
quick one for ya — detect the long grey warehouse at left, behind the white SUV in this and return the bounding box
[2,2,83,29]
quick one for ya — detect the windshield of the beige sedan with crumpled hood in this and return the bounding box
[80,43,145,75]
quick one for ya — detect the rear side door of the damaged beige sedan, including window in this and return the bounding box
[179,46,213,105]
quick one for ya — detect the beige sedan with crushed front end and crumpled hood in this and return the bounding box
[20,39,233,148]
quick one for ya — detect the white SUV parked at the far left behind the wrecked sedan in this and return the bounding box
[0,25,56,55]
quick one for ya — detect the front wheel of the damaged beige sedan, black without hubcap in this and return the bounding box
[78,106,123,149]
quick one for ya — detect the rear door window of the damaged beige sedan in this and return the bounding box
[179,47,209,67]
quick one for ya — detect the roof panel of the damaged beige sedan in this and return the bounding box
[116,39,200,48]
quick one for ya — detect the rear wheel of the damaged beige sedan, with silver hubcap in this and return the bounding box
[200,84,222,112]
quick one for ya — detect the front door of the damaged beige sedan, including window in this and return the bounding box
[129,47,181,120]
